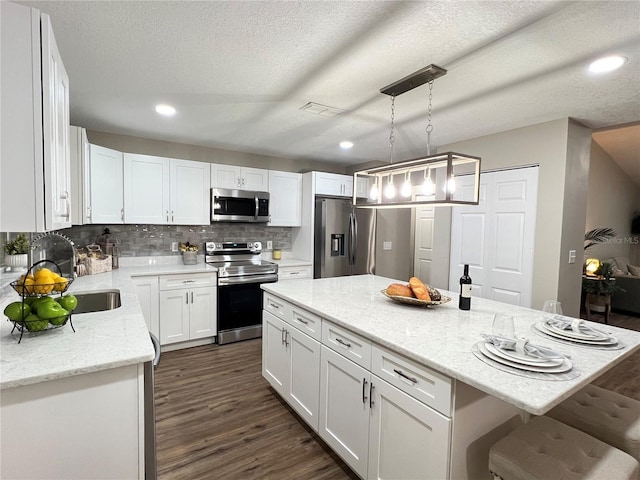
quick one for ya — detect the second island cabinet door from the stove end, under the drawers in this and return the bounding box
[285,327,320,432]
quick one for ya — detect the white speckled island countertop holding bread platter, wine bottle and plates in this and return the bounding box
[262,275,640,415]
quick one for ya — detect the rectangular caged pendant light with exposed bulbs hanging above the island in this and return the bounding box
[353,65,480,208]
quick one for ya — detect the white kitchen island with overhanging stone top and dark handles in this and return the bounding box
[262,275,640,479]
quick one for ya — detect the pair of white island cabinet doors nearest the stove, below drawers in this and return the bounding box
[262,311,320,431]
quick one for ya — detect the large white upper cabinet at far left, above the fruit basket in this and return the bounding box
[0,2,71,232]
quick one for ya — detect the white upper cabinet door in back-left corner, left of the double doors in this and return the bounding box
[89,145,124,223]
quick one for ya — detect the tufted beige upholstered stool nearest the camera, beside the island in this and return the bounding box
[489,416,640,480]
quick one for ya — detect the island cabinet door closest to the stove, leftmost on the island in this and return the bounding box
[262,310,290,398]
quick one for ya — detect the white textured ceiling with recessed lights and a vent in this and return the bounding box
[19,0,640,172]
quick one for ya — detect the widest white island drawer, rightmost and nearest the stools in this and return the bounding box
[371,345,452,417]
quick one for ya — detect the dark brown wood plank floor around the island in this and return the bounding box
[155,313,640,480]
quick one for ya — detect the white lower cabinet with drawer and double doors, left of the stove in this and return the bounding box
[159,273,217,345]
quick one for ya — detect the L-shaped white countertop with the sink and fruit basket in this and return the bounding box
[0,257,216,389]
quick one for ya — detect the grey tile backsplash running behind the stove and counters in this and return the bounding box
[53,223,291,257]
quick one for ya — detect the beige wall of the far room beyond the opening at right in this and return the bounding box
[585,142,640,265]
